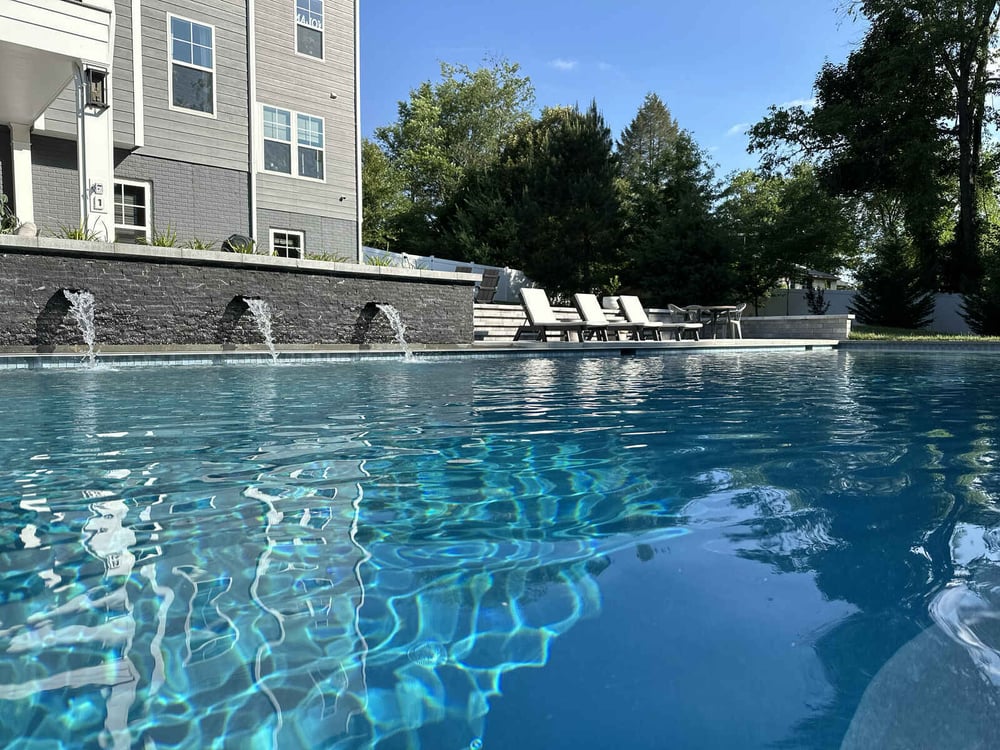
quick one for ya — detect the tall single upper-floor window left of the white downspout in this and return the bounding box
[170,16,215,115]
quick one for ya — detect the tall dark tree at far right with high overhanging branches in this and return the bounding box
[751,0,1000,296]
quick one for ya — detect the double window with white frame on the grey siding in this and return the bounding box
[263,106,324,180]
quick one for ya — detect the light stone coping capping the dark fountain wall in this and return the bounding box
[0,235,481,286]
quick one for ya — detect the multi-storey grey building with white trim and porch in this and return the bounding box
[0,0,361,260]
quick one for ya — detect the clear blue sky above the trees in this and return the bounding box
[361,0,863,177]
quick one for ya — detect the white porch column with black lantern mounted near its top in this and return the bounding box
[76,65,115,242]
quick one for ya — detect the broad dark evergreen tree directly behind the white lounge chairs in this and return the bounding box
[440,103,621,295]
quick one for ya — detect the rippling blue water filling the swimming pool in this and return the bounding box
[0,352,1000,750]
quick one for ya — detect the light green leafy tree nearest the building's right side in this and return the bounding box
[375,59,534,254]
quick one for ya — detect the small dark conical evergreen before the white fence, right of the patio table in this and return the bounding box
[849,238,934,328]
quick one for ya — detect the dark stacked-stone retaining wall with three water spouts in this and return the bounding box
[0,236,479,352]
